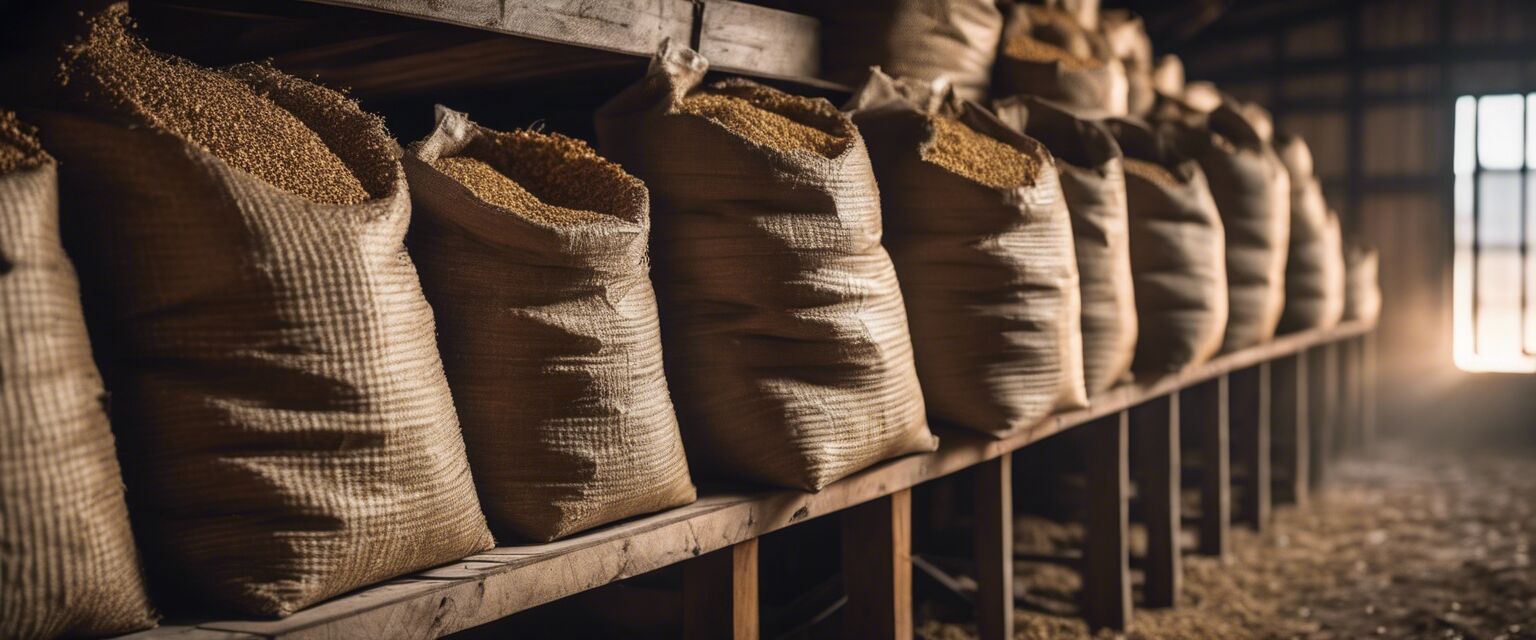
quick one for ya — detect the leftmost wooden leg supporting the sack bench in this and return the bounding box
[682,539,757,640]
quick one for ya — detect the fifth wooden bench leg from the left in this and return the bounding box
[1130,393,1181,608]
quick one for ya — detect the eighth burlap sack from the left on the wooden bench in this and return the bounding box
[1174,100,1290,351]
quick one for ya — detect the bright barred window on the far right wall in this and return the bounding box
[1453,94,1536,373]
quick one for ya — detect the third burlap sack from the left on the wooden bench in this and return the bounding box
[406,107,694,540]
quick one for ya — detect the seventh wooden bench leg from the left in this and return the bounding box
[1229,362,1270,531]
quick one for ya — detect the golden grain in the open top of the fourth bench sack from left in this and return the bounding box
[677,81,851,158]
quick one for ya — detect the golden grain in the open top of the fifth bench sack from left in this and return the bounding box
[923,117,1040,189]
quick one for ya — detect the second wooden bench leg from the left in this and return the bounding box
[842,490,912,640]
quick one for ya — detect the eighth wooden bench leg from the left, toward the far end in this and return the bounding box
[1270,353,1312,506]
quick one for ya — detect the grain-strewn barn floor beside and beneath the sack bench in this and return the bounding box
[919,444,1536,640]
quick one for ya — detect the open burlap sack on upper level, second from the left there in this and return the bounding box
[992,5,1129,115]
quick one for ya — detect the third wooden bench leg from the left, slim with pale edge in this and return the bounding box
[972,453,1014,640]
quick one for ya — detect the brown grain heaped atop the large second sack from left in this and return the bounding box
[61,5,369,204]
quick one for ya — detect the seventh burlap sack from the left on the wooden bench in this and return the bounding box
[1106,120,1227,376]
